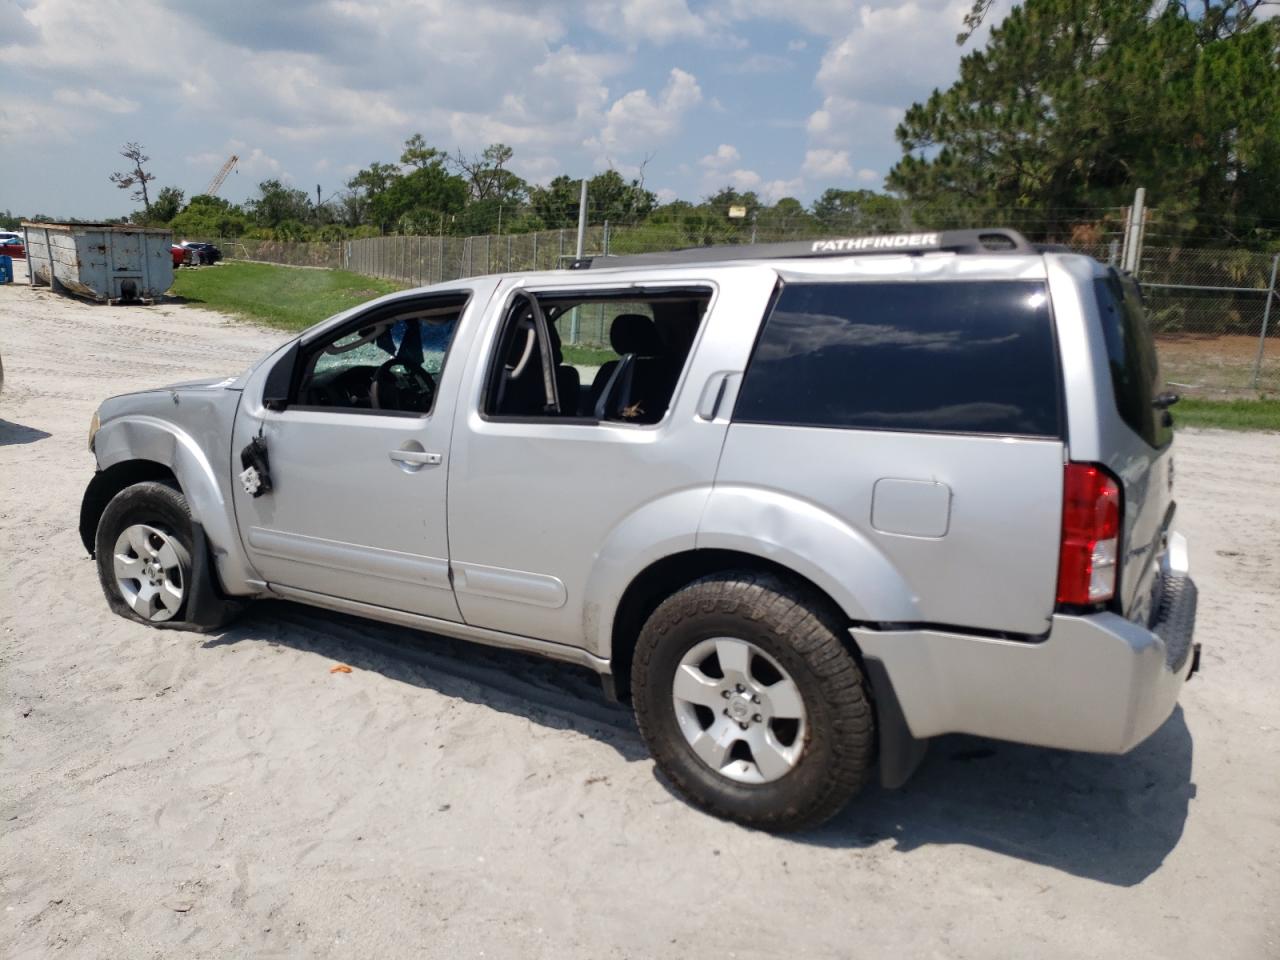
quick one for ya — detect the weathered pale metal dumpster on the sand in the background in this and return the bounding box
[22,221,173,303]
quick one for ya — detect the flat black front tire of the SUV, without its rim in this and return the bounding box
[93,480,193,626]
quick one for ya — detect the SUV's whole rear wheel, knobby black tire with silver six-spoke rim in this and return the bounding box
[631,571,876,829]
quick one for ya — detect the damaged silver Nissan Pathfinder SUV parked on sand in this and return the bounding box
[81,230,1198,829]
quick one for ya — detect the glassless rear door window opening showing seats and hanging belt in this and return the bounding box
[485,289,710,424]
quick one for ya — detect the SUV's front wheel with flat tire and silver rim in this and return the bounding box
[95,481,192,623]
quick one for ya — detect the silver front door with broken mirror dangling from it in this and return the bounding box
[232,293,467,621]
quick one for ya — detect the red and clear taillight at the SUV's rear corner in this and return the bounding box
[1057,463,1120,604]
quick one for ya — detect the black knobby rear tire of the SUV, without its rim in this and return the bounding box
[631,571,876,831]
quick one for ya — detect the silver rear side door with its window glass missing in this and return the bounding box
[449,268,773,660]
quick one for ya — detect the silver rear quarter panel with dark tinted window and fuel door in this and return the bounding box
[716,273,1064,635]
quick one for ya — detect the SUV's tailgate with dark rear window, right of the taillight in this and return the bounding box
[1093,270,1172,621]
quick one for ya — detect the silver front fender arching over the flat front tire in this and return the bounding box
[93,415,259,595]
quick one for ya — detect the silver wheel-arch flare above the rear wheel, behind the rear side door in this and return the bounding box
[698,485,920,623]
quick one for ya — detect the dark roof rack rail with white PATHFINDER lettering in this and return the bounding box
[568,227,1037,270]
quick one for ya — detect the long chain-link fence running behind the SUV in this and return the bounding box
[204,223,1280,394]
